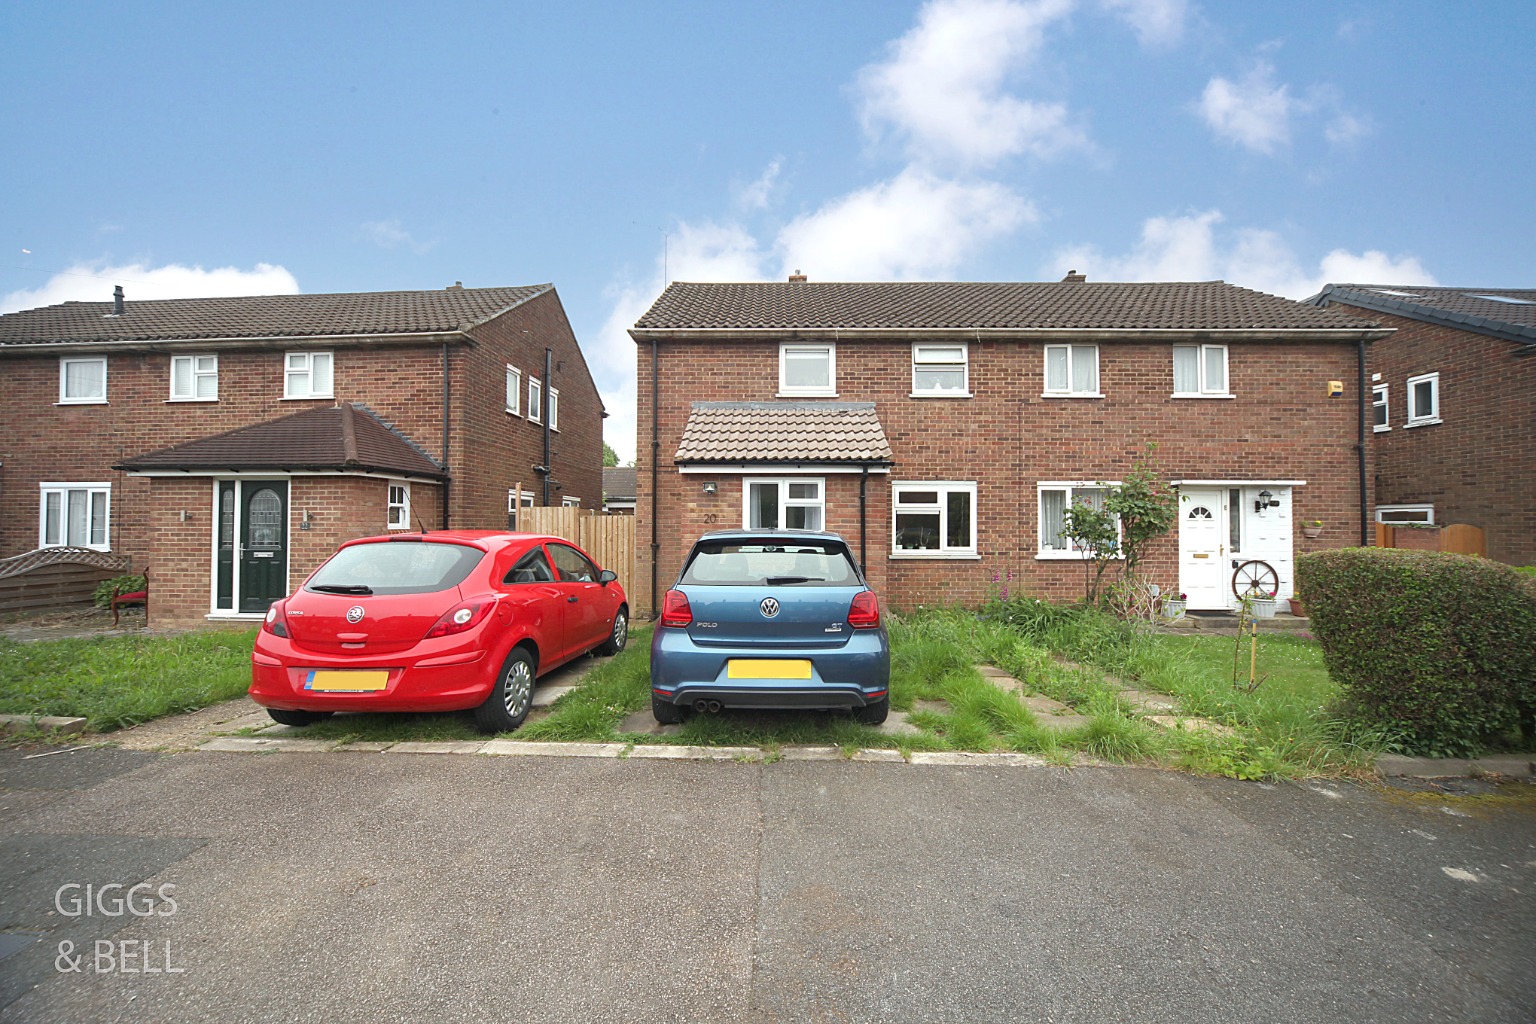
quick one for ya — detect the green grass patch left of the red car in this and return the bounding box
[0,629,257,732]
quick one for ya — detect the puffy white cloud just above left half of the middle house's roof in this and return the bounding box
[777,167,1037,281]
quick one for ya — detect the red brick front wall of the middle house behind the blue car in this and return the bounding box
[631,339,1359,608]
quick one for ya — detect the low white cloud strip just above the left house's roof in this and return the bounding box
[0,263,300,313]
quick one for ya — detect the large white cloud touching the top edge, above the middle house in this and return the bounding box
[857,0,1087,166]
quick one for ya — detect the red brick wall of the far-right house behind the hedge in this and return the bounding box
[1342,306,1536,565]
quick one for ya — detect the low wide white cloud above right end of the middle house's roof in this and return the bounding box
[1046,210,1436,299]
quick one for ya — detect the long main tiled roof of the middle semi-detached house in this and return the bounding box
[636,281,1367,333]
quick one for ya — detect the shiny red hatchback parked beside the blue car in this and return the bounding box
[250,530,630,732]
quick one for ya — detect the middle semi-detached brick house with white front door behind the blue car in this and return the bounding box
[630,273,1387,609]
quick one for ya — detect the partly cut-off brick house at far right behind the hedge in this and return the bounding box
[1307,284,1536,565]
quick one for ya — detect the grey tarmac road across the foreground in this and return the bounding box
[0,749,1536,1024]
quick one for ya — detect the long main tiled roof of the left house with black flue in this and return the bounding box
[0,284,554,348]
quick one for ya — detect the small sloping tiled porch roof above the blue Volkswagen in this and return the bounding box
[676,402,892,462]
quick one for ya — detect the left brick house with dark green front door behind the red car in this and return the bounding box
[0,284,605,623]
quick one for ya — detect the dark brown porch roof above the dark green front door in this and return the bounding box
[114,402,447,481]
